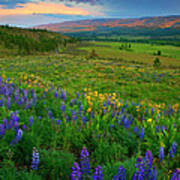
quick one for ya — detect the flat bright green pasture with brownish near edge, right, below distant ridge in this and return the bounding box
[79,42,180,67]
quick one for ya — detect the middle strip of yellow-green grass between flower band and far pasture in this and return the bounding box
[0,53,180,103]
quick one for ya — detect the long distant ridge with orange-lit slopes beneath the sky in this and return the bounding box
[35,15,180,33]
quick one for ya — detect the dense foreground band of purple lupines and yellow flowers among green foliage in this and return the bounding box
[0,78,180,180]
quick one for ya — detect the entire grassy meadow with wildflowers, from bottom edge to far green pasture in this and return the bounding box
[0,42,180,180]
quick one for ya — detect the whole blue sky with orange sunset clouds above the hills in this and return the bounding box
[0,0,180,27]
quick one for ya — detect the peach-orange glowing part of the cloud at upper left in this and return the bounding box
[0,2,91,16]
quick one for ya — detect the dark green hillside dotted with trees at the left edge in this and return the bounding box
[0,26,71,56]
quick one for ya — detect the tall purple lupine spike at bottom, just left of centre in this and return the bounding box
[81,147,90,175]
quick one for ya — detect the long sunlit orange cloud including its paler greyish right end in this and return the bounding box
[0,1,103,16]
